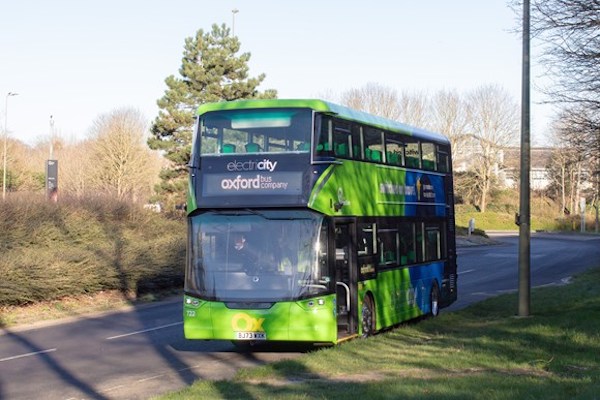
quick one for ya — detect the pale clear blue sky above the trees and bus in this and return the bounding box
[0,0,548,144]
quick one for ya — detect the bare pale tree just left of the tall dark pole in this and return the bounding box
[467,85,519,212]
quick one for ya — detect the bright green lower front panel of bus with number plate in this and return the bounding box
[183,295,337,343]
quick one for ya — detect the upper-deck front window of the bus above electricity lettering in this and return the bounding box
[199,108,312,154]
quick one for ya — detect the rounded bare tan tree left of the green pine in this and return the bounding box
[90,108,158,201]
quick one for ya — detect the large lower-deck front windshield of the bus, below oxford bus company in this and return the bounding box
[185,210,335,302]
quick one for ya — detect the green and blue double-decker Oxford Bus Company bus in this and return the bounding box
[184,100,457,343]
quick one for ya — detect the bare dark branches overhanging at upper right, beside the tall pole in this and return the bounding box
[531,0,600,211]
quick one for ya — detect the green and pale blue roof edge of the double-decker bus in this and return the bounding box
[198,99,450,144]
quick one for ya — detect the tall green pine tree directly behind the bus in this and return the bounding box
[148,24,277,208]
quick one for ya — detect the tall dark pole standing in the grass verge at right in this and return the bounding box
[517,0,531,317]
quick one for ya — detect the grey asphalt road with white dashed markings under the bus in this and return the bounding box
[0,234,600,399]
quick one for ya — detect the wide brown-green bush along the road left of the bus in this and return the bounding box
[0,196,186,306]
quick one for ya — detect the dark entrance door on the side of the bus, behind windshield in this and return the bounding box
[335,220,358,337]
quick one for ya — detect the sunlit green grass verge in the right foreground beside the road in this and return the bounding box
[160,268,600,400]
